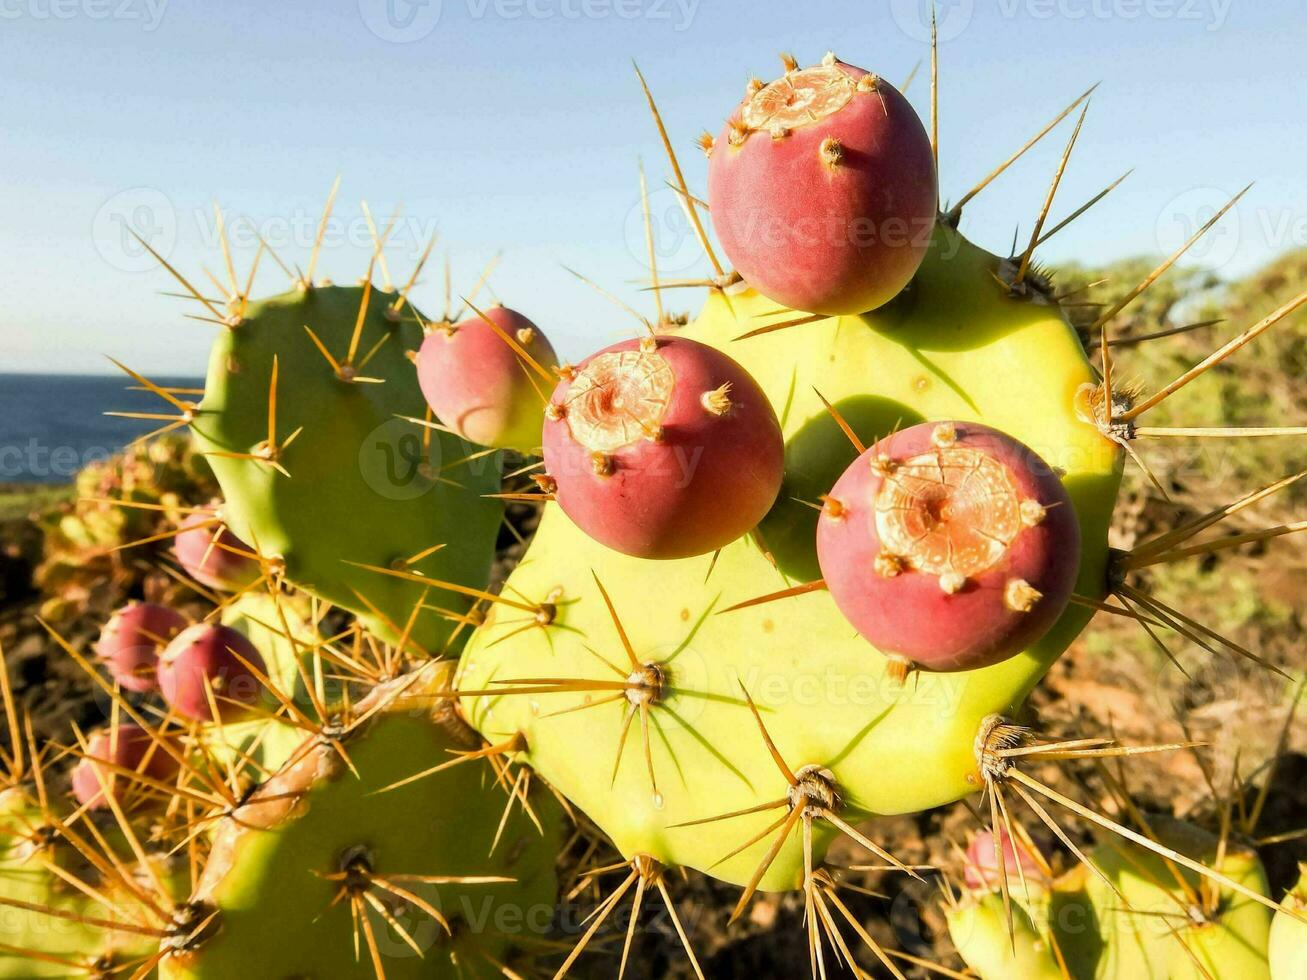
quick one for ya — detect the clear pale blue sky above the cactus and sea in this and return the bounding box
[0,0,1307,374]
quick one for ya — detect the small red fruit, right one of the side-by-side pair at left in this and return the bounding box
[158,623,267,723]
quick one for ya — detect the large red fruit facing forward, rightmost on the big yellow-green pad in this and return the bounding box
[817,422,1080,677]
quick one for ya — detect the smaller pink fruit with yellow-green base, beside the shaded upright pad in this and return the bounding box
[417,306,558,452]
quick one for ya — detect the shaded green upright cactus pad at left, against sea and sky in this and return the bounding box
[192,279,502,653]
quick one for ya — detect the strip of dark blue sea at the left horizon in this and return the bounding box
[0,374,204,483]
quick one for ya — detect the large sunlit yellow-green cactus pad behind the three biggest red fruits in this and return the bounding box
[459,227,1121,889]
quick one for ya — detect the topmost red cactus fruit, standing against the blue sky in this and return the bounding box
[704,55,938,315]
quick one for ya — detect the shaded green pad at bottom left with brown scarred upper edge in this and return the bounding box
[161,665,562,980]
